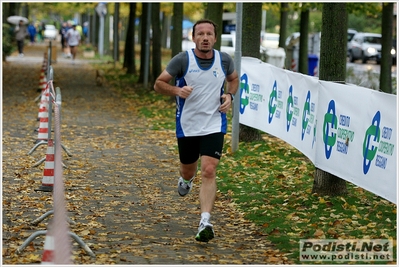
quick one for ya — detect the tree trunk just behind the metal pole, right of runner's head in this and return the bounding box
[239,2,262,142]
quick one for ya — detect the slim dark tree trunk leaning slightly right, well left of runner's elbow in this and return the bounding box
[123,2,136,74]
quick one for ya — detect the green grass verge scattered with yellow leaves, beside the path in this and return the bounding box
[96,60,397,264]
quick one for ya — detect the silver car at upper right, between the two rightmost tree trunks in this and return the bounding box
[348,32,381,63]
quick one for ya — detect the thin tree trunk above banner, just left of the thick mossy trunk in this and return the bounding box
[298,9,309,75]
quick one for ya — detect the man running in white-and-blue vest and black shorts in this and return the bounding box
[154,19,238,242]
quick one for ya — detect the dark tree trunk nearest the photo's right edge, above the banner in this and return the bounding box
[380,3,393,94]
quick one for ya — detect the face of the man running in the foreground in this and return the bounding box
[193,23,216,53]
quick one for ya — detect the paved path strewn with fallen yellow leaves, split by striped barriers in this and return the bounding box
[3,45,289,264]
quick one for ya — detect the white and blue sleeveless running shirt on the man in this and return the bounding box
[176,49,227,138]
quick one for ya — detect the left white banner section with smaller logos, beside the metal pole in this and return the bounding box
[240,57,318,162]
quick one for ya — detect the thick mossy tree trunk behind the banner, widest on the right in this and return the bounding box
[312,3,348,196]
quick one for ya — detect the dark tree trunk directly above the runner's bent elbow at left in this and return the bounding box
[151,2,162,85]
